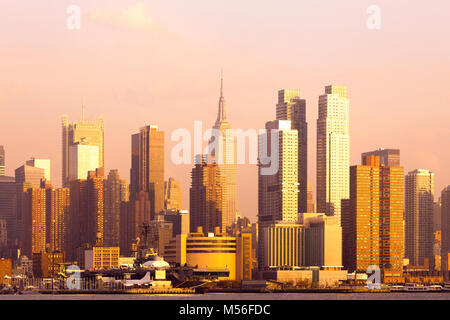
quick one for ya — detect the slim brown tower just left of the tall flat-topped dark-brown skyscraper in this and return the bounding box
[103,170,129,247]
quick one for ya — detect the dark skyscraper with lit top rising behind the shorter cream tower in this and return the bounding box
[277,90,312,212]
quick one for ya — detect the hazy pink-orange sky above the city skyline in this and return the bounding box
[0,0,450,220]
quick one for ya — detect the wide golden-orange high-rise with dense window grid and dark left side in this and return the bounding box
[341,156,404,272]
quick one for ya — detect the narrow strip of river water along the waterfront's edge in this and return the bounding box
[0,292,450,300]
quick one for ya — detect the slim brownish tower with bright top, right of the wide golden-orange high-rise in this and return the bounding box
[405,169,434,270]
